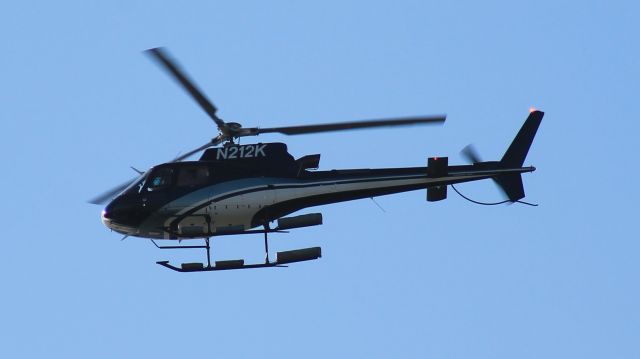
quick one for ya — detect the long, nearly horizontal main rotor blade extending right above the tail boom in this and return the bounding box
[246,115,447,135]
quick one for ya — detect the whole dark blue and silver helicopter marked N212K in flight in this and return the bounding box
[89,48,544,272]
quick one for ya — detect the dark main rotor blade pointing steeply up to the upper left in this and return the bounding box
[145,47,226,130]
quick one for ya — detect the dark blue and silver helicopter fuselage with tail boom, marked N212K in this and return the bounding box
[102,143,528,239]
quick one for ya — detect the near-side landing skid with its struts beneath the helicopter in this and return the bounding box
[152,225,322,272]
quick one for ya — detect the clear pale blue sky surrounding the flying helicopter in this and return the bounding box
[0,0,640,358]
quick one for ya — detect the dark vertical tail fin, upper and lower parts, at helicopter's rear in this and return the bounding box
[495,111,544,202]
